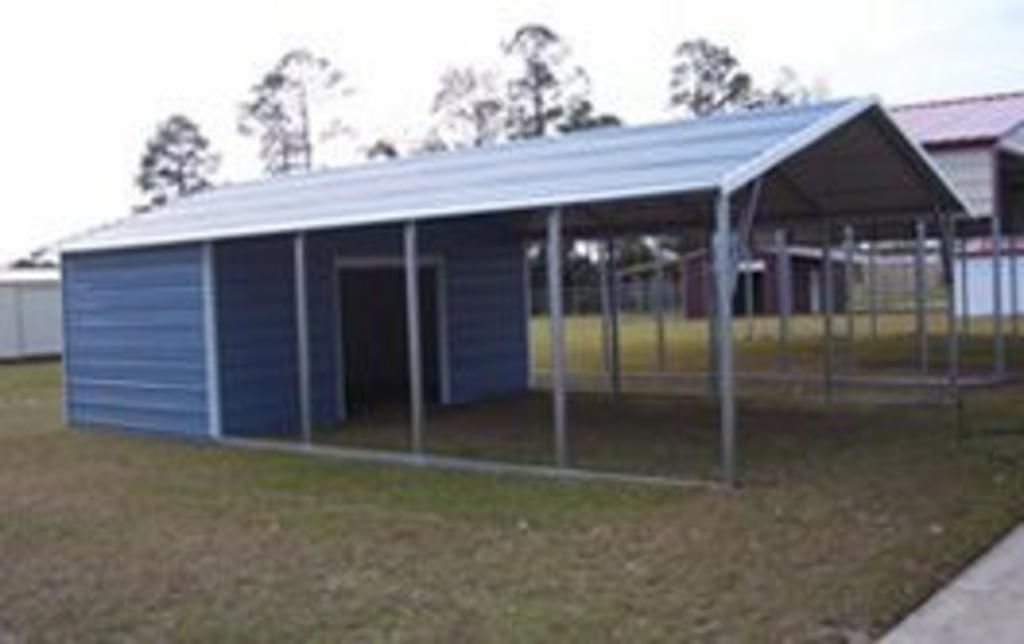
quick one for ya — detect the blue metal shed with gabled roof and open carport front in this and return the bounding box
[62,100,963,483]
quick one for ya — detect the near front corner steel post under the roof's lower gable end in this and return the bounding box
[714,192,737,486]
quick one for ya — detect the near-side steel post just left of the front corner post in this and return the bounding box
[547,208,569,468]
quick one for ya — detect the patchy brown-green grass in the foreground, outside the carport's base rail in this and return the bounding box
[0,358,1024,644]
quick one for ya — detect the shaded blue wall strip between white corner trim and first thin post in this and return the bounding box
[215,238,299,436]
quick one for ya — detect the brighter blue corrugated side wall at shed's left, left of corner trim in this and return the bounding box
[63,246,209,436]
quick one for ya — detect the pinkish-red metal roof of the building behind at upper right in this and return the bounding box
[891,91,1024,145]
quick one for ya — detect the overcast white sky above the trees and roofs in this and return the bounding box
[0,0,1024,260]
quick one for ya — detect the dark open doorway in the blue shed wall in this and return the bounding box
[338,266,440,417]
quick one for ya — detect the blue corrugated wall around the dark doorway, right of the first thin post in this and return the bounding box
[308,220,528,411]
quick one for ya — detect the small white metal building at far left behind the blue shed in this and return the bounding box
[0,269,61,360]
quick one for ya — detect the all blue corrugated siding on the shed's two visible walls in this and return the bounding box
[63,221,528,436]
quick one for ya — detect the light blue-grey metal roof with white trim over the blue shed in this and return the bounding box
[63,99,961,252]
